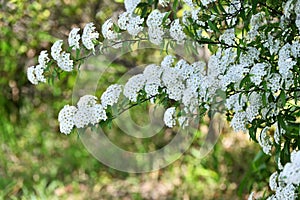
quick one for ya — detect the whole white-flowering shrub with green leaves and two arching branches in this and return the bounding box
[27,0,300,199]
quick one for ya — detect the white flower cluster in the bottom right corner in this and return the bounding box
[268,151,300,200]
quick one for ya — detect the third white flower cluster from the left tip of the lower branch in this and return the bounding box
[101,84,122,109]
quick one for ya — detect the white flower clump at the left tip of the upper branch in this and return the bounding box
[27,51,50,85]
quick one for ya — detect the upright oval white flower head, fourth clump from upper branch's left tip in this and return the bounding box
[81,23,99,52]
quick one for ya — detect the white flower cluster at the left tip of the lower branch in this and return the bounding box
[58,105,77,134]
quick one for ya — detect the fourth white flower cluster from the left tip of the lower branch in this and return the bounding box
[123,74,146,102]
